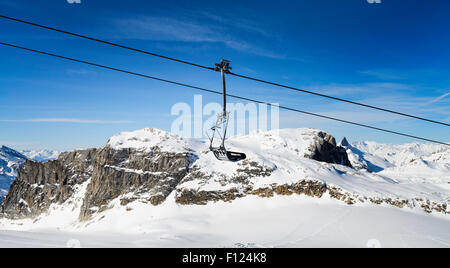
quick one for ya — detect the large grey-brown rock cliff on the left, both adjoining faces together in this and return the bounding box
[1,146,193,220]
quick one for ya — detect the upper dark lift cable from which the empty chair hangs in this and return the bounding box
[0,14,450,127]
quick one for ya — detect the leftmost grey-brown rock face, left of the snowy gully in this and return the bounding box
[1,149,96,218]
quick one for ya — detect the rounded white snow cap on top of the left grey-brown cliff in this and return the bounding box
[107,127,188,152]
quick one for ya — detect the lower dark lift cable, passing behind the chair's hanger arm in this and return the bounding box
[0,42,450,146]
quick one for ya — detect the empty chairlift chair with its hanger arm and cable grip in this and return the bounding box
[209,60,247,162]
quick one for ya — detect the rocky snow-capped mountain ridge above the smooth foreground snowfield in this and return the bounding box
[1,128,446,221]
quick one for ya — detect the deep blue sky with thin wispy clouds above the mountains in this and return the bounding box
[0,0,450,150]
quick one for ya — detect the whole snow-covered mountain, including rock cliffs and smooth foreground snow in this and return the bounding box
[0,128,450,246]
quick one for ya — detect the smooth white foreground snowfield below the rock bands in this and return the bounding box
[0,196,450,247]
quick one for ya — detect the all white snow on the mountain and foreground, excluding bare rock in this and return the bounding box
[0,128,450,247]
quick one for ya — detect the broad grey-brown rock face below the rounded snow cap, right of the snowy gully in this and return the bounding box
[80,146,192,220]
